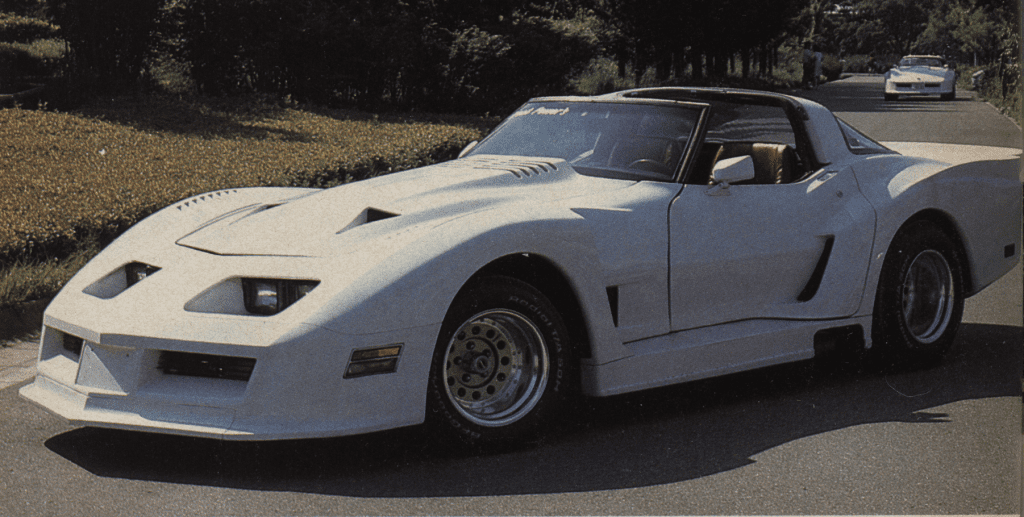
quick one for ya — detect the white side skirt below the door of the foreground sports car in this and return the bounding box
[583,315,871,396]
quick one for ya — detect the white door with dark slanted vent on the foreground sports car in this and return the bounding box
[669,167,874,331]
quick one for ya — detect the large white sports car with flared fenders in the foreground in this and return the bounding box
[20,88,1021,446]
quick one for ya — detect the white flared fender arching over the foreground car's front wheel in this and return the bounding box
[316,207,615,362]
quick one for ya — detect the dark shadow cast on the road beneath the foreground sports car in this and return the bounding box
[46,325,1024,498]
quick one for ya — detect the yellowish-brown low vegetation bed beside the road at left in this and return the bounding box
[0,97,482,265]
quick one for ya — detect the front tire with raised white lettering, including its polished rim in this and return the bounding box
[427,276,577,449]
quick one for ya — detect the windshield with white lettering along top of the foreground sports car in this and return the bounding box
[468,101,700,180]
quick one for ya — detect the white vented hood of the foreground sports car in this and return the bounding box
[177,157,635,257]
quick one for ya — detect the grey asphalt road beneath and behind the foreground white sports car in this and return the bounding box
[0,77,1024,516]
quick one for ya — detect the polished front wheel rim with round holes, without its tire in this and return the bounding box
[442,309,549,427]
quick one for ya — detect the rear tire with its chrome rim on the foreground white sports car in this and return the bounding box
[871,221,964,365]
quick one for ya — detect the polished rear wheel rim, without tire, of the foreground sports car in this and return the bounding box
[902,250,954,343]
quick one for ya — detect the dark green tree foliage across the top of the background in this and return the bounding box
[19,0,1020,112]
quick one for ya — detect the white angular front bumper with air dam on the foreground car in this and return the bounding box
[20,316,437,440]
